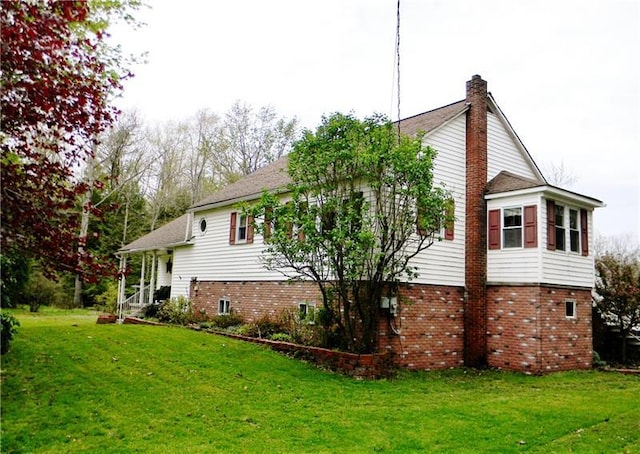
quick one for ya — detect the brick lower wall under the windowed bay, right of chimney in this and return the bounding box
[487,285,592,374]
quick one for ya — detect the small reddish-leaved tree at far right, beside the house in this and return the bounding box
[595,239,640,363]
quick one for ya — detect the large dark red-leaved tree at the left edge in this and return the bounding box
[0,1,135,276]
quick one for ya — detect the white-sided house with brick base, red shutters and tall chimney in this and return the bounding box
[121,76,603,373]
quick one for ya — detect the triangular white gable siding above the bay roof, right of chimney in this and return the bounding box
[487,112,536,180]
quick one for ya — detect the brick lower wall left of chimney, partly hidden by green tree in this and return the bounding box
[191,281,464,370]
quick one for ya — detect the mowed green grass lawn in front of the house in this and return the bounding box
[1,310,640,453]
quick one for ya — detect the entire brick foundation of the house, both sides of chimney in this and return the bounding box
[191,281,592,374]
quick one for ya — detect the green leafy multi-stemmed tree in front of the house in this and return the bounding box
[247,114,453,353]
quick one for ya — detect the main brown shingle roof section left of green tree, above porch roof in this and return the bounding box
[191,156,291,209]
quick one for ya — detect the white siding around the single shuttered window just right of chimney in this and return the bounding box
[487,194,546,283]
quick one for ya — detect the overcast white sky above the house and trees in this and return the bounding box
[112,0,640,241]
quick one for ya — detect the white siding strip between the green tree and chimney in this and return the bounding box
[411,115,466,286]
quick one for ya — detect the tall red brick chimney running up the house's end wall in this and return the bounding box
[464,75,487,367]
